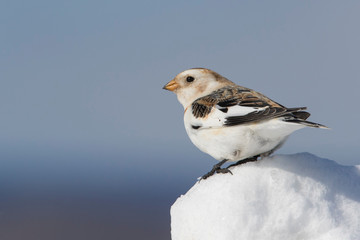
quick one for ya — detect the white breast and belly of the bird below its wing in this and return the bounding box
[184,108,304,161]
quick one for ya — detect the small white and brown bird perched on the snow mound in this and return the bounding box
[163,68,327,179]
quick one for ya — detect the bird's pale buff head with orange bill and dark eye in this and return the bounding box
[163,68,234,108]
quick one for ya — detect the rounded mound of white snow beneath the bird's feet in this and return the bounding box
[171,153,360,240]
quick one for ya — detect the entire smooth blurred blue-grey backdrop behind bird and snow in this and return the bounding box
[0,0,360,240]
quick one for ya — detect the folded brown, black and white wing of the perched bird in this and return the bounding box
[192,86,305,128]
